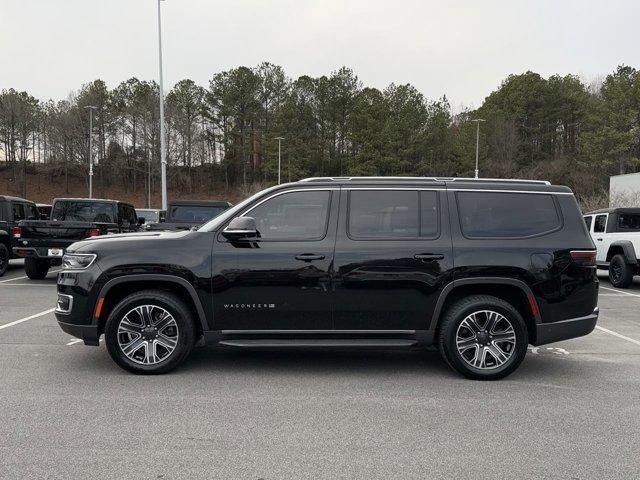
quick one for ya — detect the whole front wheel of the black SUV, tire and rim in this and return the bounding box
[104,290,195,375]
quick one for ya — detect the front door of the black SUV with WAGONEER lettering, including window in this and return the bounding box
[212,188,339,331]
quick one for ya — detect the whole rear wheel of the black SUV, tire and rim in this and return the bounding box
[438,295,529,380]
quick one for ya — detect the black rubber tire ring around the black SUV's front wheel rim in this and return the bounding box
[104,290,196,375]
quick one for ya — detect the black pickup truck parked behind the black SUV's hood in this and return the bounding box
[13,198,139,279]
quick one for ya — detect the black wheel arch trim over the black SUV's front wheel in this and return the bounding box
[93,274,208,334]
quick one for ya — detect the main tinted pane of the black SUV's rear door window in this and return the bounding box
[349,190,420,238]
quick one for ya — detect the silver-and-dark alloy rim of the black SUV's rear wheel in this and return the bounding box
[456,310,516,370]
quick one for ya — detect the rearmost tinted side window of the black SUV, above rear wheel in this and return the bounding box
[457,192,560,238]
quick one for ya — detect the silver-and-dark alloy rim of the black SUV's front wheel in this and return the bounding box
[118,305,179,365]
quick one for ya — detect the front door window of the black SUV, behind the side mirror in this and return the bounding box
[244,190,331,241]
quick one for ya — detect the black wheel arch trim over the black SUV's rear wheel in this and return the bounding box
[429,277,542,343]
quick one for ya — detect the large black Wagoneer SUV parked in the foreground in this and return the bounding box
[56,177,598,379]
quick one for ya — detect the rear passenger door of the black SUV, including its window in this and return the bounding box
[334,182,453,330]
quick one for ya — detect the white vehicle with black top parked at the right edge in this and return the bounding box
[584,208,640,288]
